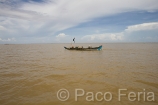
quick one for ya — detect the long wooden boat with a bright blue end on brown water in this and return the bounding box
[64,45,102,51]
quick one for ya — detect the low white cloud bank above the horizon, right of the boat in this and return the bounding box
[81,22,158,42]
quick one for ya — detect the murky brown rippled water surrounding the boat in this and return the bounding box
[0,43,158,105]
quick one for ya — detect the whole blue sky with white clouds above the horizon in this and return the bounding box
[0,0,158,44]
